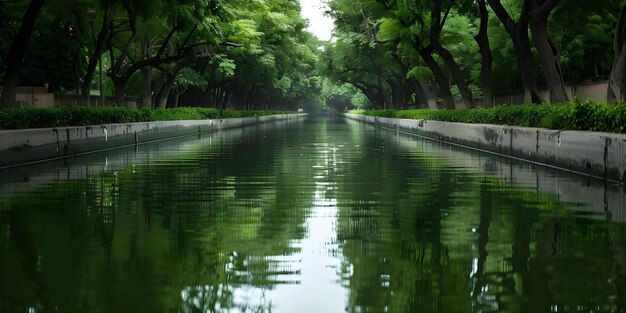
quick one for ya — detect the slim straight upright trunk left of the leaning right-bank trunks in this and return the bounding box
[474,0,493,108]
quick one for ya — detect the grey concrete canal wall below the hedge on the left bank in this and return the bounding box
[0,114,306,168]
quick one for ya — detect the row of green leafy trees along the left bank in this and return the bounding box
[0,0,321,109]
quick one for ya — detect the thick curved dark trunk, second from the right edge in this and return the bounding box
[530,0,569,103]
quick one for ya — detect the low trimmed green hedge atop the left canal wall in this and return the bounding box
[0,106,284,129]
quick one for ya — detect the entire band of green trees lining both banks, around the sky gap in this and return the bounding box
[0,0,626,110]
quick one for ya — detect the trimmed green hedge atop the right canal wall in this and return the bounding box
[349,100,626,133]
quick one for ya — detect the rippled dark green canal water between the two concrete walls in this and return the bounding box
[0,118,626,312]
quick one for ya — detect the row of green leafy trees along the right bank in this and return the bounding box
[323,0,626,109]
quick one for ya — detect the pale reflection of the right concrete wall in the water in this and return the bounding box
[396,133,626,223]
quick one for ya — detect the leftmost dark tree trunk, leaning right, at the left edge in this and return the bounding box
[0,0,46,107]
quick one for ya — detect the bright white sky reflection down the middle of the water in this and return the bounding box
[219,146,348,313]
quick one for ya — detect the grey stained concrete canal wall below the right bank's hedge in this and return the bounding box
[344,114,626,183]
